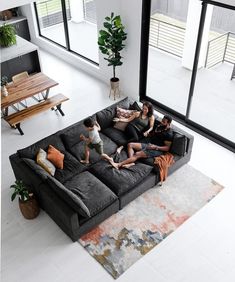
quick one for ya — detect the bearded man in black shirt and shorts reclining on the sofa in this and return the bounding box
[110,115,173,169]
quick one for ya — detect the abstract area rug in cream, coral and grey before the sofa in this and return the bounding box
[79,165,223,279]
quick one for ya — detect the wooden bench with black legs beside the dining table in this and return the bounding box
[5,94,69,135]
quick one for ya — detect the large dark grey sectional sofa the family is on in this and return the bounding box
[10,98,193,241]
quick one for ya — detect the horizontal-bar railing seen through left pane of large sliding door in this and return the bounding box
[149,17,185,57]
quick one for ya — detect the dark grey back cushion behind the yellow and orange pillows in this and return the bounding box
[17,133,65,160]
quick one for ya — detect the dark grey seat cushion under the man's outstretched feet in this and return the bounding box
[89,160,152,196]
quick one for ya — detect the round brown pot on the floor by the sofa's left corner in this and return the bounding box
[19,196,40,219]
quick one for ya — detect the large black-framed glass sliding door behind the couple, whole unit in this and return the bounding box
[140,0,235,150]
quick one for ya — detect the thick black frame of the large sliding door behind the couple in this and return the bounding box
[139,0,235,152]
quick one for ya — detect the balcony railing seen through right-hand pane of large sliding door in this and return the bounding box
[205,32,235,68]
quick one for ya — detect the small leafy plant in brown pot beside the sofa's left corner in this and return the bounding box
[10,180,40,219]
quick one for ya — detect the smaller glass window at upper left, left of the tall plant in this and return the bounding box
[35,0,98,63]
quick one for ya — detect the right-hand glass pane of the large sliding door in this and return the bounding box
[189,7,235,142]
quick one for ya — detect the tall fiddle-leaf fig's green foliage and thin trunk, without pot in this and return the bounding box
[98,13,127,78]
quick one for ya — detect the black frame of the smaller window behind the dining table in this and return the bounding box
[34,0,99,66]
